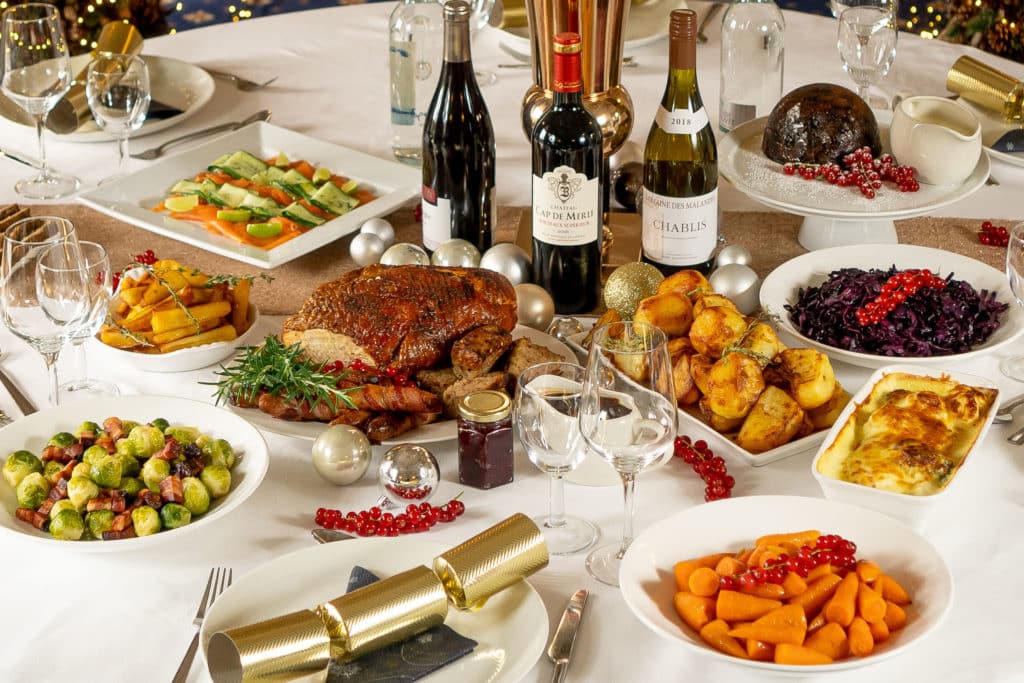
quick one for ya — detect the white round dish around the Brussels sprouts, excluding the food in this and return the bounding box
[0,395,269,553]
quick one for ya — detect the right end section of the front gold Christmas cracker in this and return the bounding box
[434,513,548,610]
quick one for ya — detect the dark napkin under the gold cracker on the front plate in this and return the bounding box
[327,566,477,683]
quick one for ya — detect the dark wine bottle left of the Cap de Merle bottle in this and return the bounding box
[422,0,497,252]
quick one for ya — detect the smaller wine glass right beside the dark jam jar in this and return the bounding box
[516,362,597,555]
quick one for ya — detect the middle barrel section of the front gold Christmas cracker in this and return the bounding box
[316,566,449,663]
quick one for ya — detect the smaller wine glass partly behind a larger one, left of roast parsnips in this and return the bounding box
[60,242,120,398]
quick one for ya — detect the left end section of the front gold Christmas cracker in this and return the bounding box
[207,609,331,683]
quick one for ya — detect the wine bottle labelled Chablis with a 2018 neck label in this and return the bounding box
[642,9,718,274]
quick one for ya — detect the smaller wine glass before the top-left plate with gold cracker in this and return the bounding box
[85,52,150,184]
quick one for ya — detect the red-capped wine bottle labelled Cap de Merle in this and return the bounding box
[532,33,605,313]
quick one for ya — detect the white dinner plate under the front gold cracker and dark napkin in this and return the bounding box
[200,538,548,683]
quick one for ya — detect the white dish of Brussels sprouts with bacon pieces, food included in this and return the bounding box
[0,396,269,552]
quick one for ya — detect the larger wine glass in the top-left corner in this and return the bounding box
[0,2,79,200]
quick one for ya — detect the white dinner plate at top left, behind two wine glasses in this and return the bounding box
[0,54,216,142]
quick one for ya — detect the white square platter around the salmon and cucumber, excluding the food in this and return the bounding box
[78,122,422,268]
